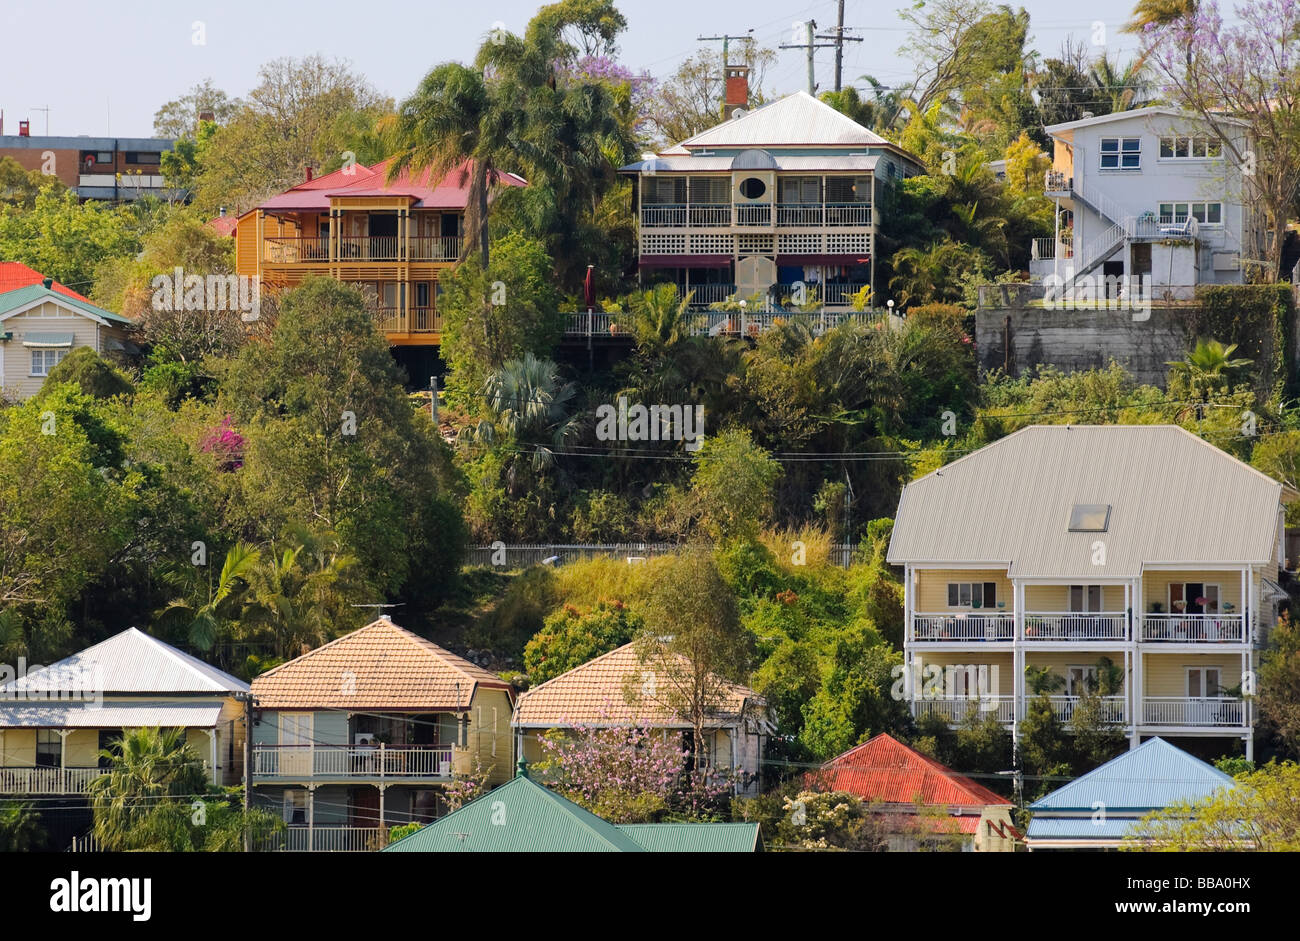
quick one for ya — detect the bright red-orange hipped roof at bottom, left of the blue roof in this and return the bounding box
[810,733,1011,807]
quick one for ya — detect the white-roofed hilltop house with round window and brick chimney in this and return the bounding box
[619,83,924,308]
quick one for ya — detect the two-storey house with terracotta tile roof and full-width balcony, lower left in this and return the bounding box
[248,617,514,851]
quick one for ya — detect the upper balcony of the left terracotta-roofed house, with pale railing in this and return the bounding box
[252,745,454,782]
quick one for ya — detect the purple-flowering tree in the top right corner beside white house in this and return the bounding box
[1128,0,1300,281]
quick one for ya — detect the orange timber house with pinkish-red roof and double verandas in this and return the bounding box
[234,160,525,383]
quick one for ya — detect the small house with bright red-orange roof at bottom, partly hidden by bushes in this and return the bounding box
[809,733,1021,853]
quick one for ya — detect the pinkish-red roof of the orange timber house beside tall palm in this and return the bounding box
[257,160,525,212]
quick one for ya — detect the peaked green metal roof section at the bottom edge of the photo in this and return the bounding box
[384,775,645,853]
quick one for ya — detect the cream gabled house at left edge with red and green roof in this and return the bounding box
[0,261,139,399]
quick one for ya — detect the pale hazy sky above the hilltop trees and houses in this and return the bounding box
[0,0,1136,136]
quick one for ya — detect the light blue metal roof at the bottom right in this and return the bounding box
[1030,738,1236,821]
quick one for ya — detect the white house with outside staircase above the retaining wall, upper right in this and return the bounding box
[1030,107,1253,299]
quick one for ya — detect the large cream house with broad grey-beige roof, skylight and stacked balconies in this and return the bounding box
[888,425,1296,756]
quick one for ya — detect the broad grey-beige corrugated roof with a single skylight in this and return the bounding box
[889,425,1282,578]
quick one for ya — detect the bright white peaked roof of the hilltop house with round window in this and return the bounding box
[664,91,893,155]
